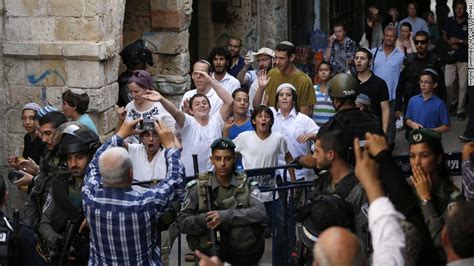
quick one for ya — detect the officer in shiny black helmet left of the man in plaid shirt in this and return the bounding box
[38,122,100,265]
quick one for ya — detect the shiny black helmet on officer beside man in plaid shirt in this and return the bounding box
[59,122,100,155]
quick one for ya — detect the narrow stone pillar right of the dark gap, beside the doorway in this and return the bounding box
[123,0,192,102]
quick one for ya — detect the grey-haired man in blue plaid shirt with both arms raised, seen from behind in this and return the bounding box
[82,120,184,265]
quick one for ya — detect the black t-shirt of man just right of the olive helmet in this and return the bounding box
[359,73,389,118]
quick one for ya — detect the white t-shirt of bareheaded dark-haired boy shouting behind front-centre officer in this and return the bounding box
[234,131,288,202]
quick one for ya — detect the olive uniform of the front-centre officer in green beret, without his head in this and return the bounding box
[178,173,266,265]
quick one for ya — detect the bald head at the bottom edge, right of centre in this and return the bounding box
[314,227,363,266]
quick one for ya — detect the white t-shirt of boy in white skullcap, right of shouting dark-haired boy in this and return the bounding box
[270,107,319,180]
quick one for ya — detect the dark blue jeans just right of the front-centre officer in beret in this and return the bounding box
[265,199,289,265]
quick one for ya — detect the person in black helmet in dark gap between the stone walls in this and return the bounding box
[117,39,153,107]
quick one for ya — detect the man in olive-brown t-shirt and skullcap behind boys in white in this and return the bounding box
[253,41,316,117]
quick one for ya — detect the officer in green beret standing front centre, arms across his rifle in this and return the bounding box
[178,137,266,265]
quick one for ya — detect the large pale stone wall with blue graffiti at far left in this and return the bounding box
[0,0,125,165]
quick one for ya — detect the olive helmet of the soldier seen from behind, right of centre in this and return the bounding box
[328,73,360,98]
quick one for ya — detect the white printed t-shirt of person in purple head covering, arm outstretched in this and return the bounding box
[125,101,176,143]
